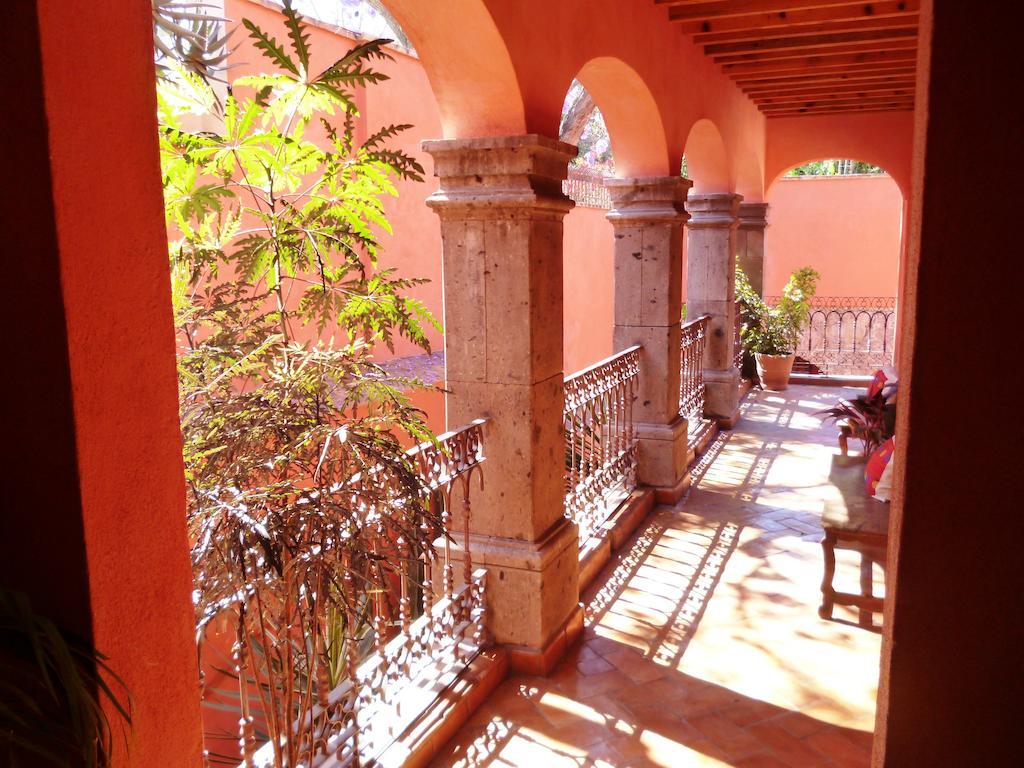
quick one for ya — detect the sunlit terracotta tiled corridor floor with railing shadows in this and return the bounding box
[433,387,880,768]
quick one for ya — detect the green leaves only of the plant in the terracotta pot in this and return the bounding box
[736,266,821,354]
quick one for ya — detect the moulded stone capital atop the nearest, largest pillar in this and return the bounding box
[423,133,577,219]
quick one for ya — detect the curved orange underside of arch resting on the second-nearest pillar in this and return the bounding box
[577,56,670,176]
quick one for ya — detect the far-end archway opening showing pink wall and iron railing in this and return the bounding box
[762,158,905,376]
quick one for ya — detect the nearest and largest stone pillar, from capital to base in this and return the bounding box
[424,135,583,674]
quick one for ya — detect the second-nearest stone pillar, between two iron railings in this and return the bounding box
[605,176,690,503]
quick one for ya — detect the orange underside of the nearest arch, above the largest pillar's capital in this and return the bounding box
[384,0,526,138]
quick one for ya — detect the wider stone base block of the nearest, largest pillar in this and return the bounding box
[444,517,580,655]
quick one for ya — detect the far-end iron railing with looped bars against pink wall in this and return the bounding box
[766,296,896,375]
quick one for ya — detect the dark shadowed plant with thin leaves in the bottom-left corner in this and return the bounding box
[0,589,131,768]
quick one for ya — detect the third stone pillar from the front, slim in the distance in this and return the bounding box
[686,193,742,429]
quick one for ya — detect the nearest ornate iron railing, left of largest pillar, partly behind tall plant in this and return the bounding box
[242,420,486,768]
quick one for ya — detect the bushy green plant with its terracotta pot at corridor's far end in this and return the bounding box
[736,266,821,391]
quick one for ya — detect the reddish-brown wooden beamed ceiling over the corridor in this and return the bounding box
[654,0,921,117]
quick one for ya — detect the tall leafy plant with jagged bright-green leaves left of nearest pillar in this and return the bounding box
[158,2,441,768]
